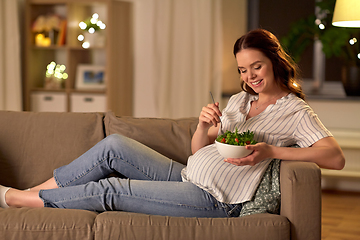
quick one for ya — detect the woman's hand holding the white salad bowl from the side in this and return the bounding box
[225,142,272,166]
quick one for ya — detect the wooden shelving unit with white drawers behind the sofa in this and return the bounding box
[24,0,133,116]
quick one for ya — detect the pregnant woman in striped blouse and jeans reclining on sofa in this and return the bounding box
[0,29,345,217]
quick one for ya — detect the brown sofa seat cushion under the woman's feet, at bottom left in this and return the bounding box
[0,208,97,240]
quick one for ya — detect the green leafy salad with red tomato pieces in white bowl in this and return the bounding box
[216,128,257,146]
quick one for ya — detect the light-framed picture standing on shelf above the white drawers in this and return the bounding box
[75,64,106,90]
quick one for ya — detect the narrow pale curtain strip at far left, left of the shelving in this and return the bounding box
[0,0,22,111]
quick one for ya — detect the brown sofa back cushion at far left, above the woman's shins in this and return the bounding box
[0,111,105,189]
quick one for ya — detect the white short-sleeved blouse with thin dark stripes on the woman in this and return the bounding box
[181,92,332,204]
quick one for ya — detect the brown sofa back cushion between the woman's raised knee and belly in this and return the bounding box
[104,112,198,164]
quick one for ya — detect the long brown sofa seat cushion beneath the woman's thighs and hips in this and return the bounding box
[94,212,290,240]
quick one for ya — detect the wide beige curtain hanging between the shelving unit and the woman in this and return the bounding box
[134,0,222,118]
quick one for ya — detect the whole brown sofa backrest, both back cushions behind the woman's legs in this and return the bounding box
[0,111,198,189]
